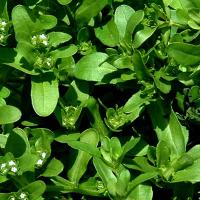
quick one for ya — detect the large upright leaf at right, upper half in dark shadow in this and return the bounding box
[149,100,188,156]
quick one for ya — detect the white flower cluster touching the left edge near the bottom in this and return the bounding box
[0,160,19,175]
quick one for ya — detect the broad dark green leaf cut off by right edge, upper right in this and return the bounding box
[167,42,200,66]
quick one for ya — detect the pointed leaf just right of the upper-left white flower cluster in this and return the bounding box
[47,32,72,47]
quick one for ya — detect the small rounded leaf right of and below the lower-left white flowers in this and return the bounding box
[41,158,64,177]
